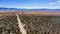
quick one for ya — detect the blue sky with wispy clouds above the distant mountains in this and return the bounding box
[0,0,60,9]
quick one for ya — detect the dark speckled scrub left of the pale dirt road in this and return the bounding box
[0,15,21,34]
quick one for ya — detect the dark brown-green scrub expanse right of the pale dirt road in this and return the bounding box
[20,15,60,34]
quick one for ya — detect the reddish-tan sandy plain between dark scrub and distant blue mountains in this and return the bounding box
[0,11,60,16]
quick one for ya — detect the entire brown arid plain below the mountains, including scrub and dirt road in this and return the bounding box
[0,11,60,34]
